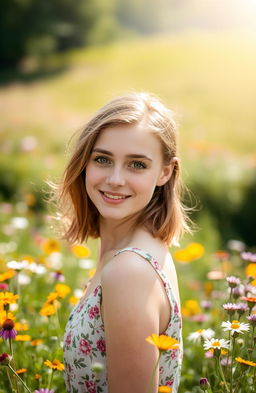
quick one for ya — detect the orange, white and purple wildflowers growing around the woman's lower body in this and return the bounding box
[0,202,256,393]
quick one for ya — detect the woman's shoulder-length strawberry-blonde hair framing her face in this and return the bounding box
[49,93,194,244]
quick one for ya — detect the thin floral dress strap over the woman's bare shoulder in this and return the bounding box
[114,247,178,311]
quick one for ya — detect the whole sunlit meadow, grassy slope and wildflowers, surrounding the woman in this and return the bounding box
[0,32,256,393]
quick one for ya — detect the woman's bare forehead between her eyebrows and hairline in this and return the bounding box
[94,123,161,156]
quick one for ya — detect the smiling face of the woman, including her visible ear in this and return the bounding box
[86,123,172,220]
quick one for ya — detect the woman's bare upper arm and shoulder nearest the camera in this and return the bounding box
[101,253,161,393]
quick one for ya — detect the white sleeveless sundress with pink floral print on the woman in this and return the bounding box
[64,247,183,393]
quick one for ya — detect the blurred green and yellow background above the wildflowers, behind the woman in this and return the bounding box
[0,0,256,390]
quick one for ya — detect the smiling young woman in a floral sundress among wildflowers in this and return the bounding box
[59,93,193,393]
